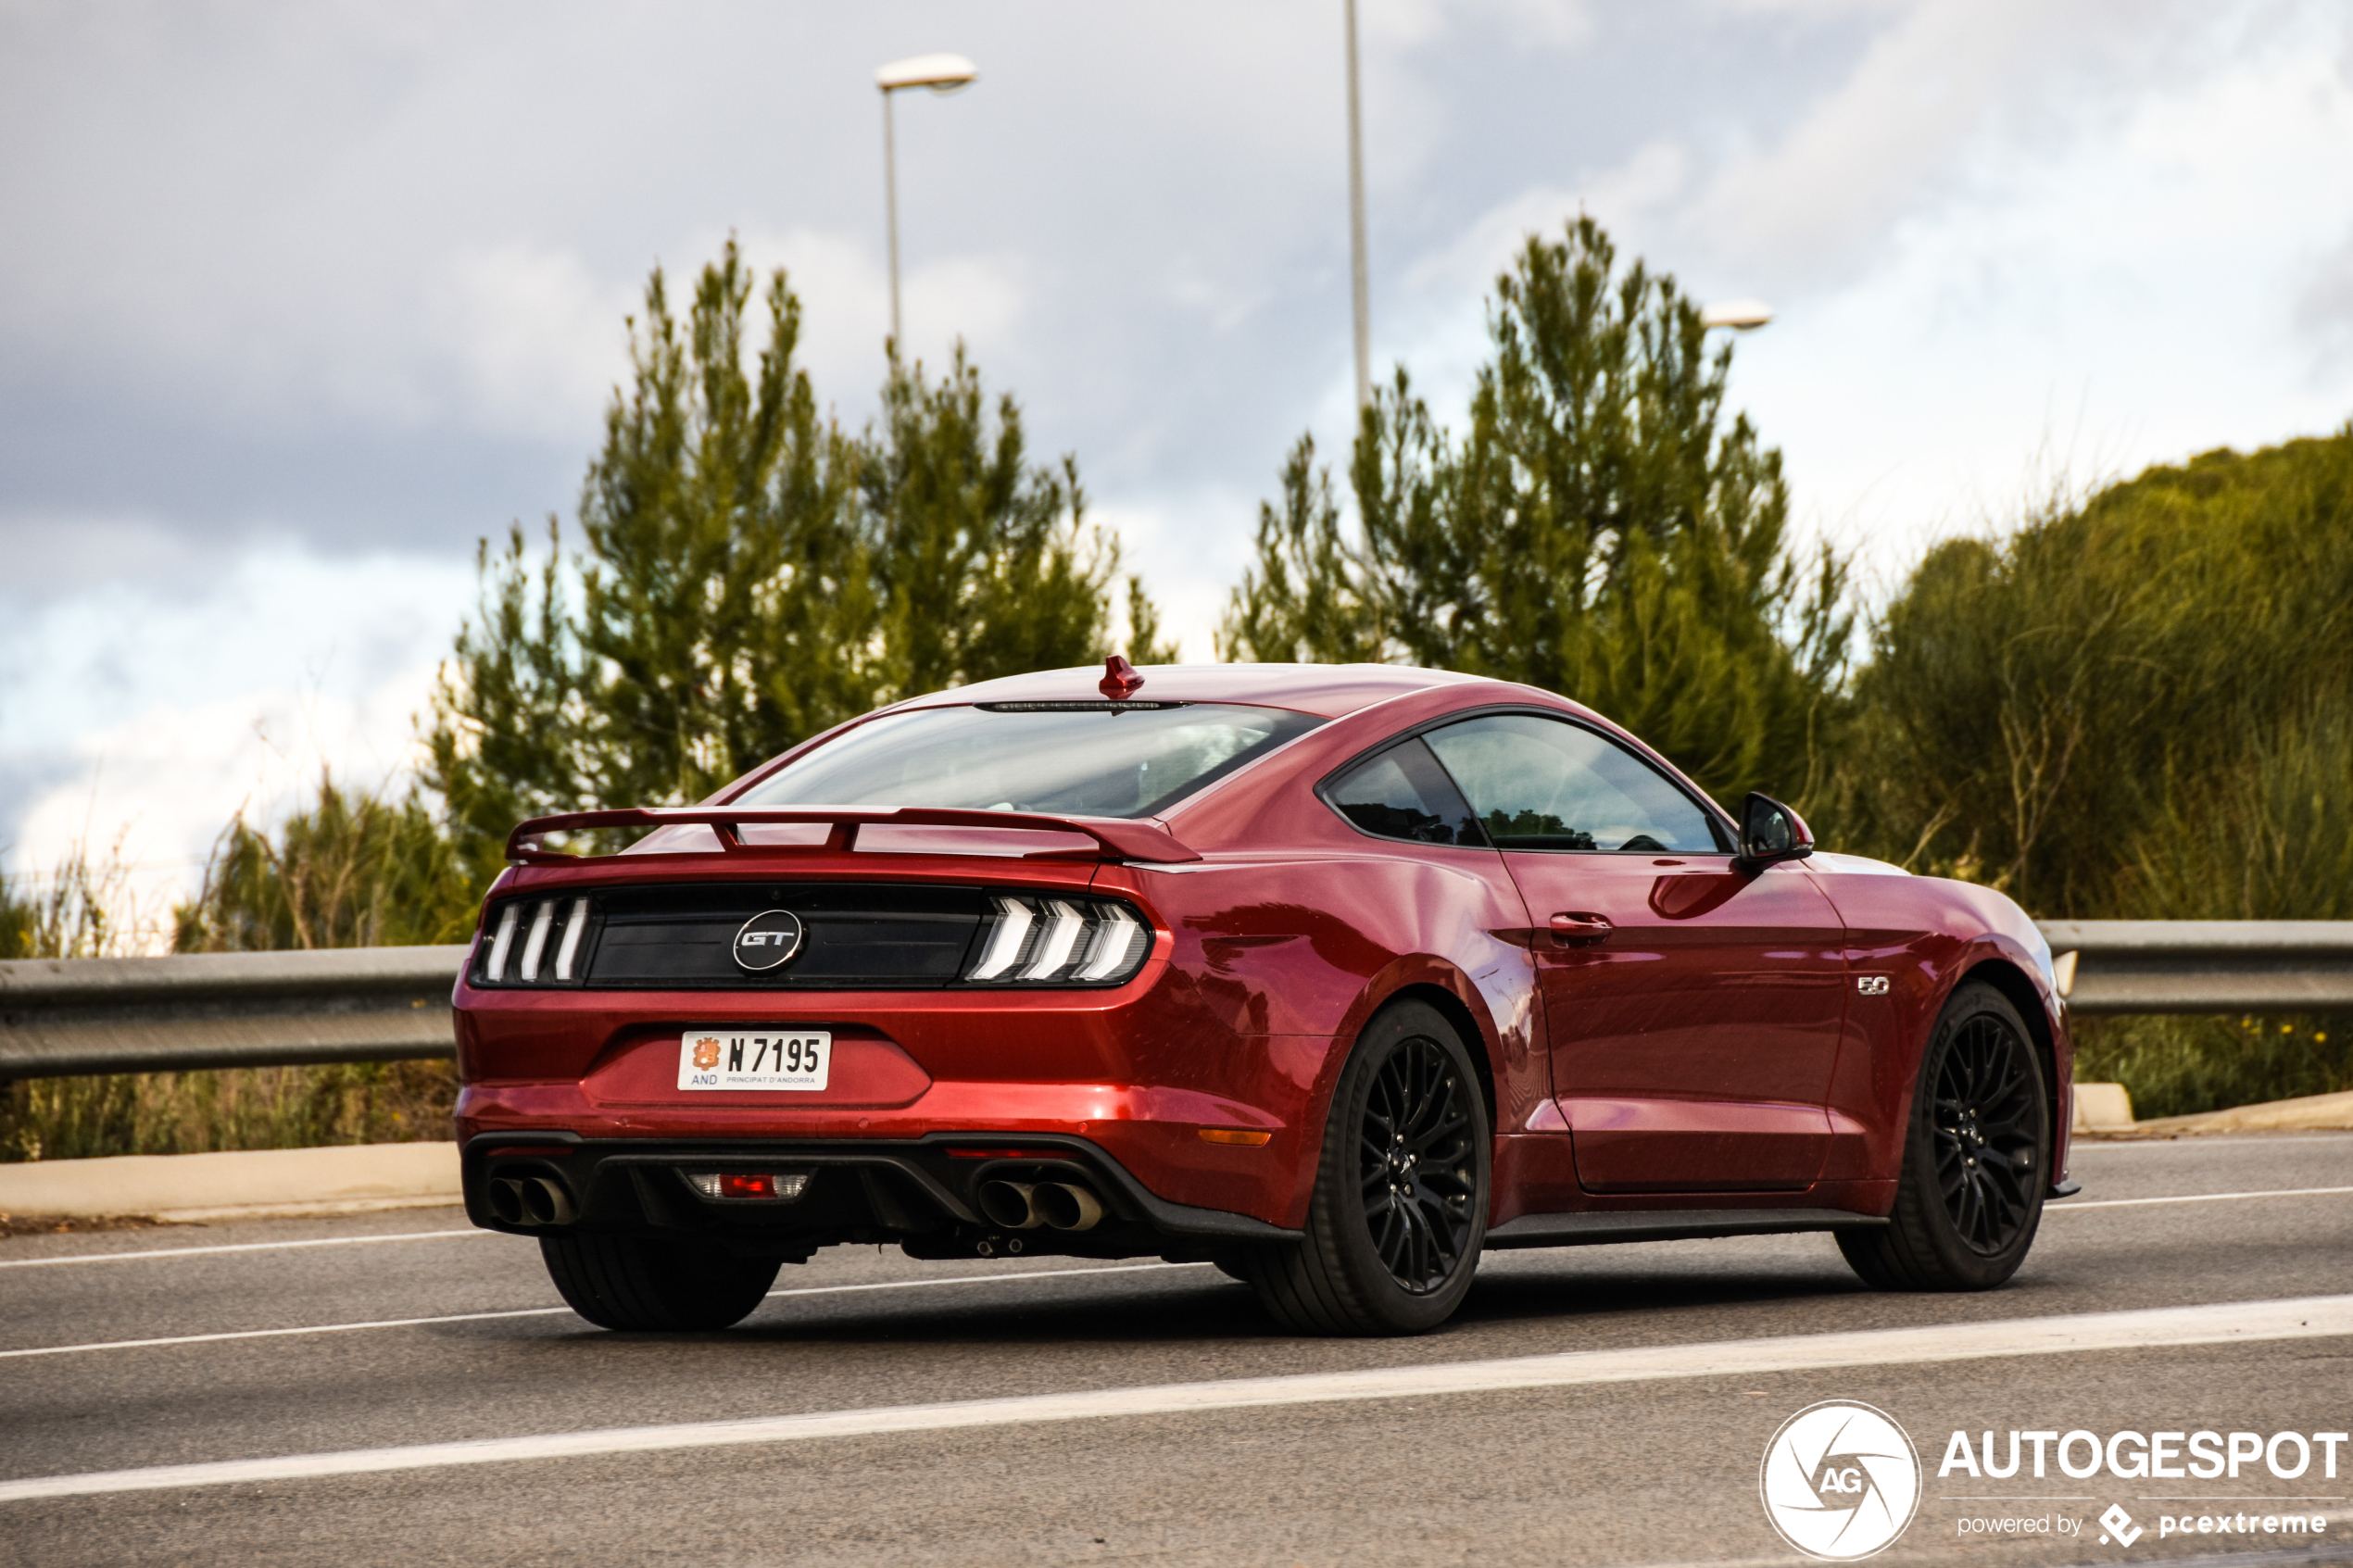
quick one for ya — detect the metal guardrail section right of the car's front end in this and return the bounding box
[2040,919,2353,1013]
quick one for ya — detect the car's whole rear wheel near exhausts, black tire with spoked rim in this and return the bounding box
[1233,1001,1494,1336]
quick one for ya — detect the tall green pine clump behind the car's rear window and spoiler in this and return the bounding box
[423,242,1169,879]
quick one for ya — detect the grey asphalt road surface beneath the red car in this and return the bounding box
[0,1135,2353,1568]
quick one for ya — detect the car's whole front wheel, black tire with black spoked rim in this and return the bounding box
[1838,980,2052,1290]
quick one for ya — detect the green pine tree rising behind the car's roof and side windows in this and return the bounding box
[1219,219,1849,797]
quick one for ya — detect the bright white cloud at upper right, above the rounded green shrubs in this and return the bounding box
[1737,6,2353,585]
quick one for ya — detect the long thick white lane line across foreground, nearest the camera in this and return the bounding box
[0,1296,2353,1502]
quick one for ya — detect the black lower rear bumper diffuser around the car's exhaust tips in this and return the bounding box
[461,1131,1299,1258]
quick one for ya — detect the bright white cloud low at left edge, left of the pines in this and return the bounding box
[0,546,473,931]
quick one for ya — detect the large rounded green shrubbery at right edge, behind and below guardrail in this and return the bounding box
[1821,430,2353,1117]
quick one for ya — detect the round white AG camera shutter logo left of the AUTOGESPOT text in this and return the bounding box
[1757,1399,1920,1563]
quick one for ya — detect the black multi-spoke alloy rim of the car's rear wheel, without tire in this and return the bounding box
[1358,1036,1478,1296]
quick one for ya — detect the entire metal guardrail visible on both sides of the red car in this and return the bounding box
[0,919,2353,1079]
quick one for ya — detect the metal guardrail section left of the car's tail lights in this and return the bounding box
[0,947,466,1079]
